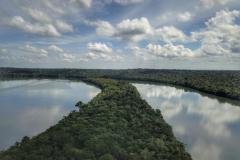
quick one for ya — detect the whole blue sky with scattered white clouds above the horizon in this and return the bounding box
[0,0,240,70]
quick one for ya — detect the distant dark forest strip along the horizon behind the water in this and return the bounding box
[0,68,240,100]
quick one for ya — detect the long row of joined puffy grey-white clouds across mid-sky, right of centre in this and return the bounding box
[89,17,188,42]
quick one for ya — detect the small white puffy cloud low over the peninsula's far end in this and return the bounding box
[86,42,122,61]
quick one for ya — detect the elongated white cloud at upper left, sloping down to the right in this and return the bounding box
[9,16,61,37]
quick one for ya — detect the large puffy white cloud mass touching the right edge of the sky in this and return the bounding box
[192,10,240,55]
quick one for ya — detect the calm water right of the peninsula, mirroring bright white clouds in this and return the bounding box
[134,83,240,160]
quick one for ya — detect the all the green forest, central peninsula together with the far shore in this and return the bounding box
[0,68,240,160]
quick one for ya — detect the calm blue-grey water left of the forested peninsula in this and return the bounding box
[0,80,100,150]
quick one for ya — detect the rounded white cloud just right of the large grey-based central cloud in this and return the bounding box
[154,26,186,42]
